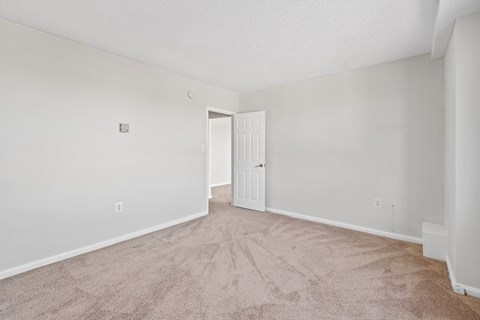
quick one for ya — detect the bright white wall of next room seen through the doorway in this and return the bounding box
[209,117,232,186]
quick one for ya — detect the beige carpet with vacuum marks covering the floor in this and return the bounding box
[0,187,480,320]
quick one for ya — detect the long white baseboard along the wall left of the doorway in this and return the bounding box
[0,212,208,280]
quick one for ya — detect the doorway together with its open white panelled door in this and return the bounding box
[206,108,266,212]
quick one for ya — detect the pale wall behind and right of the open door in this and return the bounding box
[240,55,444,236]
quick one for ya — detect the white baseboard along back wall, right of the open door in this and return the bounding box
[266,208,423,244]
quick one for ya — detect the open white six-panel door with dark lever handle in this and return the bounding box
[233,111,265,212]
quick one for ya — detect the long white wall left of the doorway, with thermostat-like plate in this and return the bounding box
[0,20,238,272]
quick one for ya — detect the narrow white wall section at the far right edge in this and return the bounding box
[445,14,480,295]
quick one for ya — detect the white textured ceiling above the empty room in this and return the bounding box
[0,0,437,92]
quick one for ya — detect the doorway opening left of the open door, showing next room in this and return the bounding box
[207,108,233,210]
